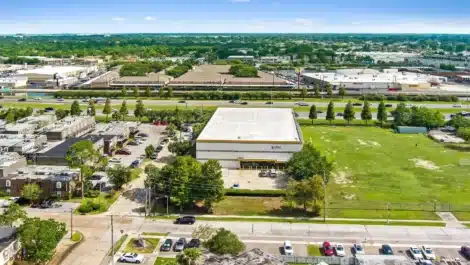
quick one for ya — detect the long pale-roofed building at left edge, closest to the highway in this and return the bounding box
[2,114,57,134]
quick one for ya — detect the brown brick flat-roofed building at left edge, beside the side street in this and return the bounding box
[0,165,80,198]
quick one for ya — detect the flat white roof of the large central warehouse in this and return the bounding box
[197,108,301,143]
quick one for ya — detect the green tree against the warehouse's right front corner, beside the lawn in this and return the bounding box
[284,143,333,183]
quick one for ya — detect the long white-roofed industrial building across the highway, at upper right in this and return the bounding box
[302,69,447,91]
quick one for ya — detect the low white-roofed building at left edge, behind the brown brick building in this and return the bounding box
[0,134,47,154]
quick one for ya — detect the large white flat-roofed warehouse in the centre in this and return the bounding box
[196,108,303,168]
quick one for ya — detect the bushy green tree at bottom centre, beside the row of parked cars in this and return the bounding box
[204,228,245,256]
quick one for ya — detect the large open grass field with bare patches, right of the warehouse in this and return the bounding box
[302,126,470,219]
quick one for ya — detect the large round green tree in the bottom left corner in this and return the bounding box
[19,218,67,264]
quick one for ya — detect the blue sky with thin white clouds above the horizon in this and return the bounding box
[0,0,470,34]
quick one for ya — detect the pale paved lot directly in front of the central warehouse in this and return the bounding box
[222,168,287,190]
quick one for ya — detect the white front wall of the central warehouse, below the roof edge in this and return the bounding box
[196,142,302,168]
